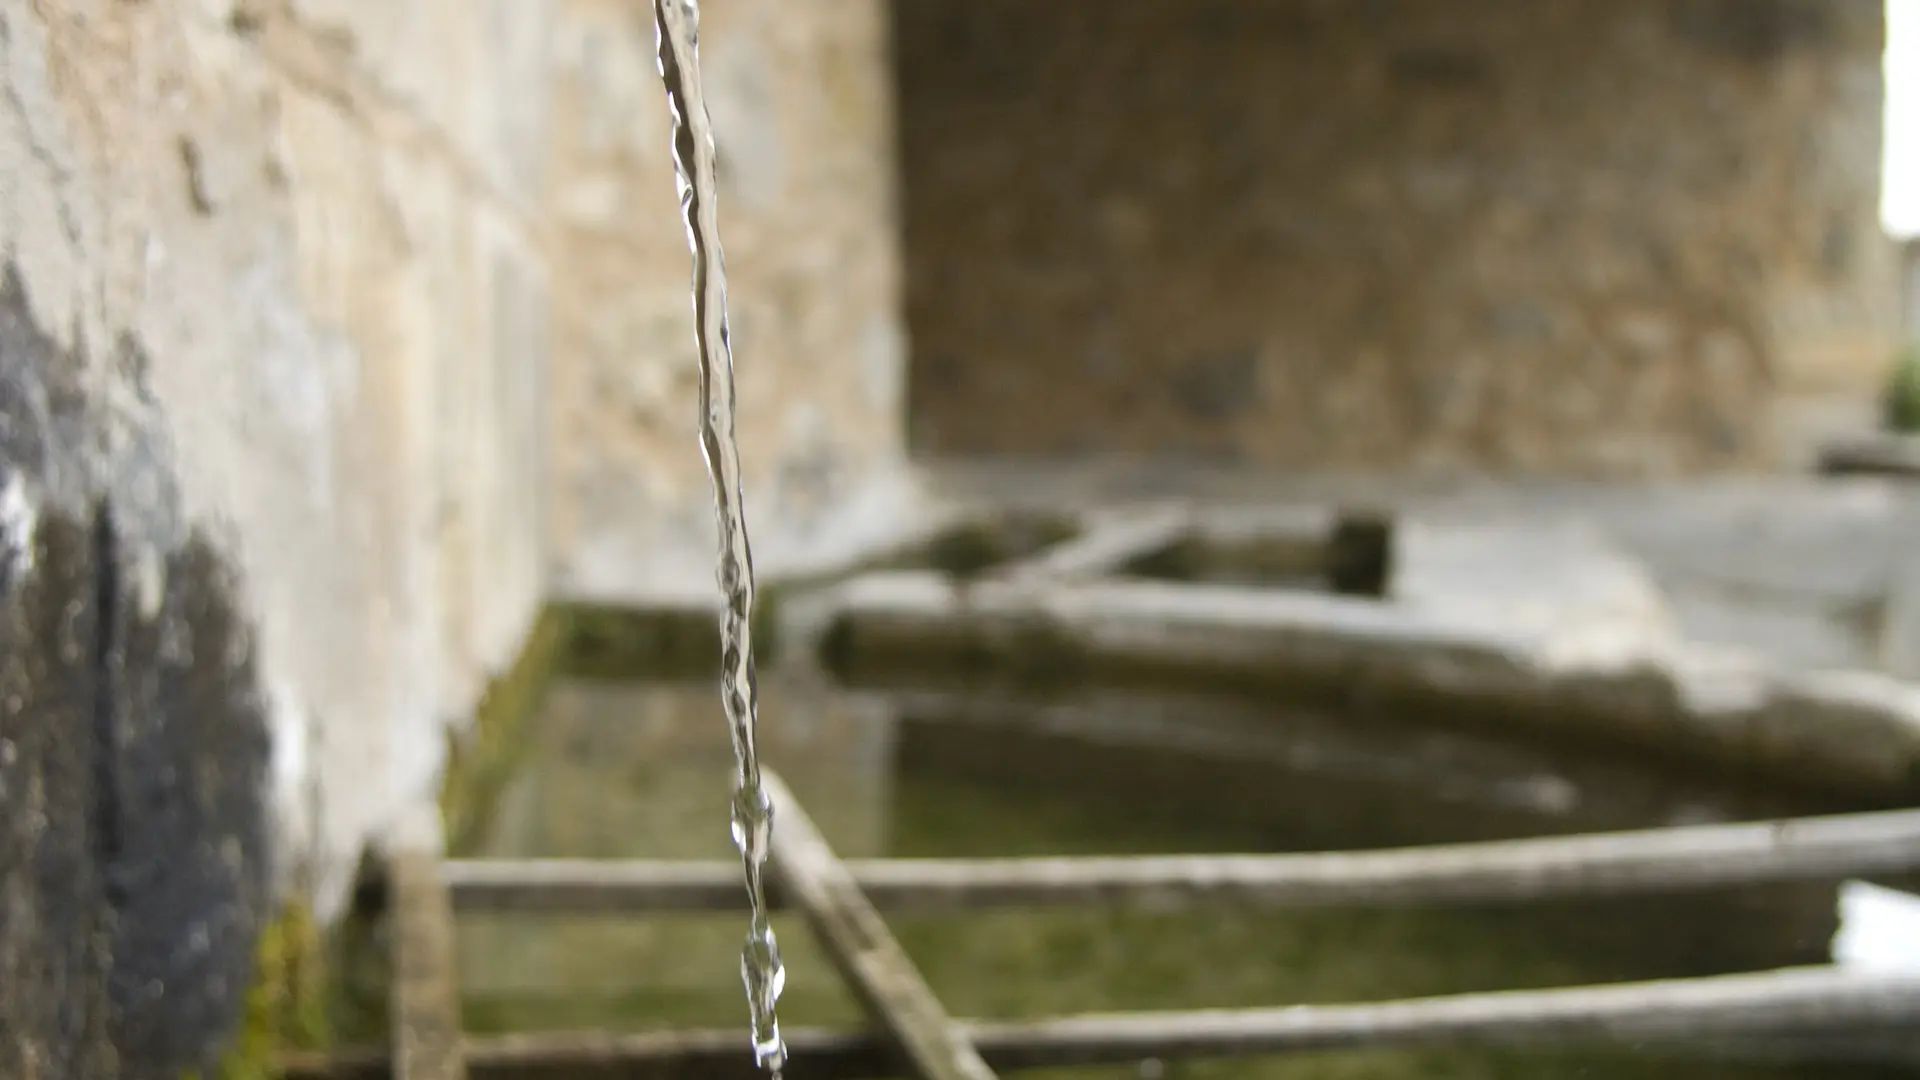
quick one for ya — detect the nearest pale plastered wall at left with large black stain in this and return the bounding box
[0,0,551,1080]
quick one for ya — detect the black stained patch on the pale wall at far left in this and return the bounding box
[0,265,269,1080]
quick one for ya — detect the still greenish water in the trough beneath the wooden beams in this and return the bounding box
[461,675,1912,1080]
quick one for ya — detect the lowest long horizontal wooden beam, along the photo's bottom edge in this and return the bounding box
[284,969,1920,1080]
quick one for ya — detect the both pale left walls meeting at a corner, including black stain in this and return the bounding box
[0,0,912,1078]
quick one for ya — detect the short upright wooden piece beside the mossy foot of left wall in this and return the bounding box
[386,809,467,1080]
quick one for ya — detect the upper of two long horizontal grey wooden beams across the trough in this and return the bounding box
[444,807,1920,915]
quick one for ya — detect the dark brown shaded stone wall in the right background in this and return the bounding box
[895,0,1897,475]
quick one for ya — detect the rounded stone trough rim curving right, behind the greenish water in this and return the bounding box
[820,573,1920,801]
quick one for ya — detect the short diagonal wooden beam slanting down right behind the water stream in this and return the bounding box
[760,773,993,1080]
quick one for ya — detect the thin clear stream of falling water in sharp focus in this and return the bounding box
[653,0,787,1080]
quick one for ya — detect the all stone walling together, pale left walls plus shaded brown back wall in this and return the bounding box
[0,0,1897,1078]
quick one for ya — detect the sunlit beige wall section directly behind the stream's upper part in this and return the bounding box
[549,0,912,596]
